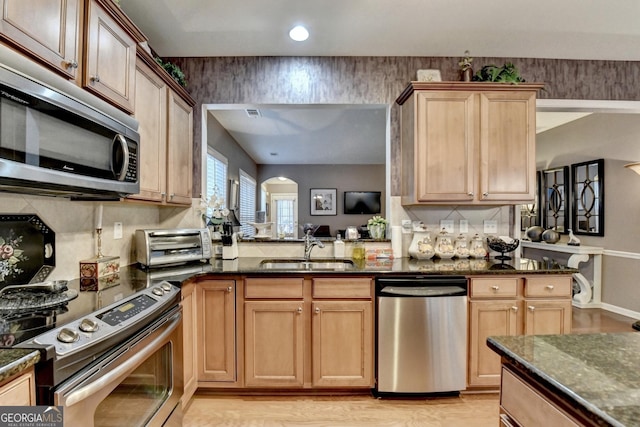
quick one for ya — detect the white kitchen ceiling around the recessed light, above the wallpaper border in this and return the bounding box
[121,0,640,61]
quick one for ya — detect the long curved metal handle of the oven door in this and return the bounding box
[62,312,182,406]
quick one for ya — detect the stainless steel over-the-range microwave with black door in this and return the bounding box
[0,46,140,200]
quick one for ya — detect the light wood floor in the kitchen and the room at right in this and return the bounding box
[183,309,640,427]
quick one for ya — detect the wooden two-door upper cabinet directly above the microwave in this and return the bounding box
[0,0,146,113]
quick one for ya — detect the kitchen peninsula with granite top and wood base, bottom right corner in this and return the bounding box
[487,332,640,427]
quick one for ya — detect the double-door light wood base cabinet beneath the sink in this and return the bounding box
[244,277,374,388]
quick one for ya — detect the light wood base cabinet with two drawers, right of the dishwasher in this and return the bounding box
[468,274,572,387]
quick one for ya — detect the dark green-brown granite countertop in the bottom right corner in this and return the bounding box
[487,332,640,427]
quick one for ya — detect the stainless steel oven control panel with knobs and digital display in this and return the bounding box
[34,281,180,357]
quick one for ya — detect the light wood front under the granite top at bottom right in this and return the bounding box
[500,368,581,427]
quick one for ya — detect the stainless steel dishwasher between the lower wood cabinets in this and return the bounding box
[376,275,467,396]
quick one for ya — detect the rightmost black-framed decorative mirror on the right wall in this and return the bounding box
[571,159,604,236]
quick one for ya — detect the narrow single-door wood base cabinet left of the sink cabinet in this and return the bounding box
[196,279,237,383]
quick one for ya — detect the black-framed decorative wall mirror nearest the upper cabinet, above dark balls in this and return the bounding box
[541,166,569,234]
